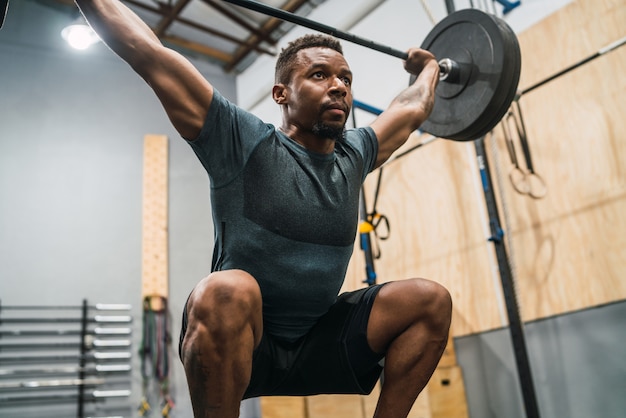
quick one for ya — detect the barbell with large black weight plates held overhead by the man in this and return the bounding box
[224,0,522,141]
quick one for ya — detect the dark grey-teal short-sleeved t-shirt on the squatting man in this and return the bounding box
[190,91,378,340]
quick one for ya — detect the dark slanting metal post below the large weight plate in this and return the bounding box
[474,137,539,418]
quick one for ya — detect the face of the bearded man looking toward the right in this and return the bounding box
[278,47,352,139]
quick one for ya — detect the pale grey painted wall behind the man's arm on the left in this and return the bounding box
[0,0,236,417]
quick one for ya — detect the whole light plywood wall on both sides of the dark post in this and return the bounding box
[345,0,626,335]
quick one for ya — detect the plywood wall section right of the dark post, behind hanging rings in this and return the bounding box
[490,0,626,320]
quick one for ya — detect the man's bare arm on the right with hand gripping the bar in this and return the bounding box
[371,48,439,167]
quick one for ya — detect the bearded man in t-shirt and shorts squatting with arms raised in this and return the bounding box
[76,0,452,418]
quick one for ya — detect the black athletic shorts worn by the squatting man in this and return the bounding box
[179,284,384,399]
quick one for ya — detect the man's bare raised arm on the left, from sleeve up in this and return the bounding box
[75,0,213,140]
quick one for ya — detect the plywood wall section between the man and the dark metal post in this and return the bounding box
[347,138,503,334]
